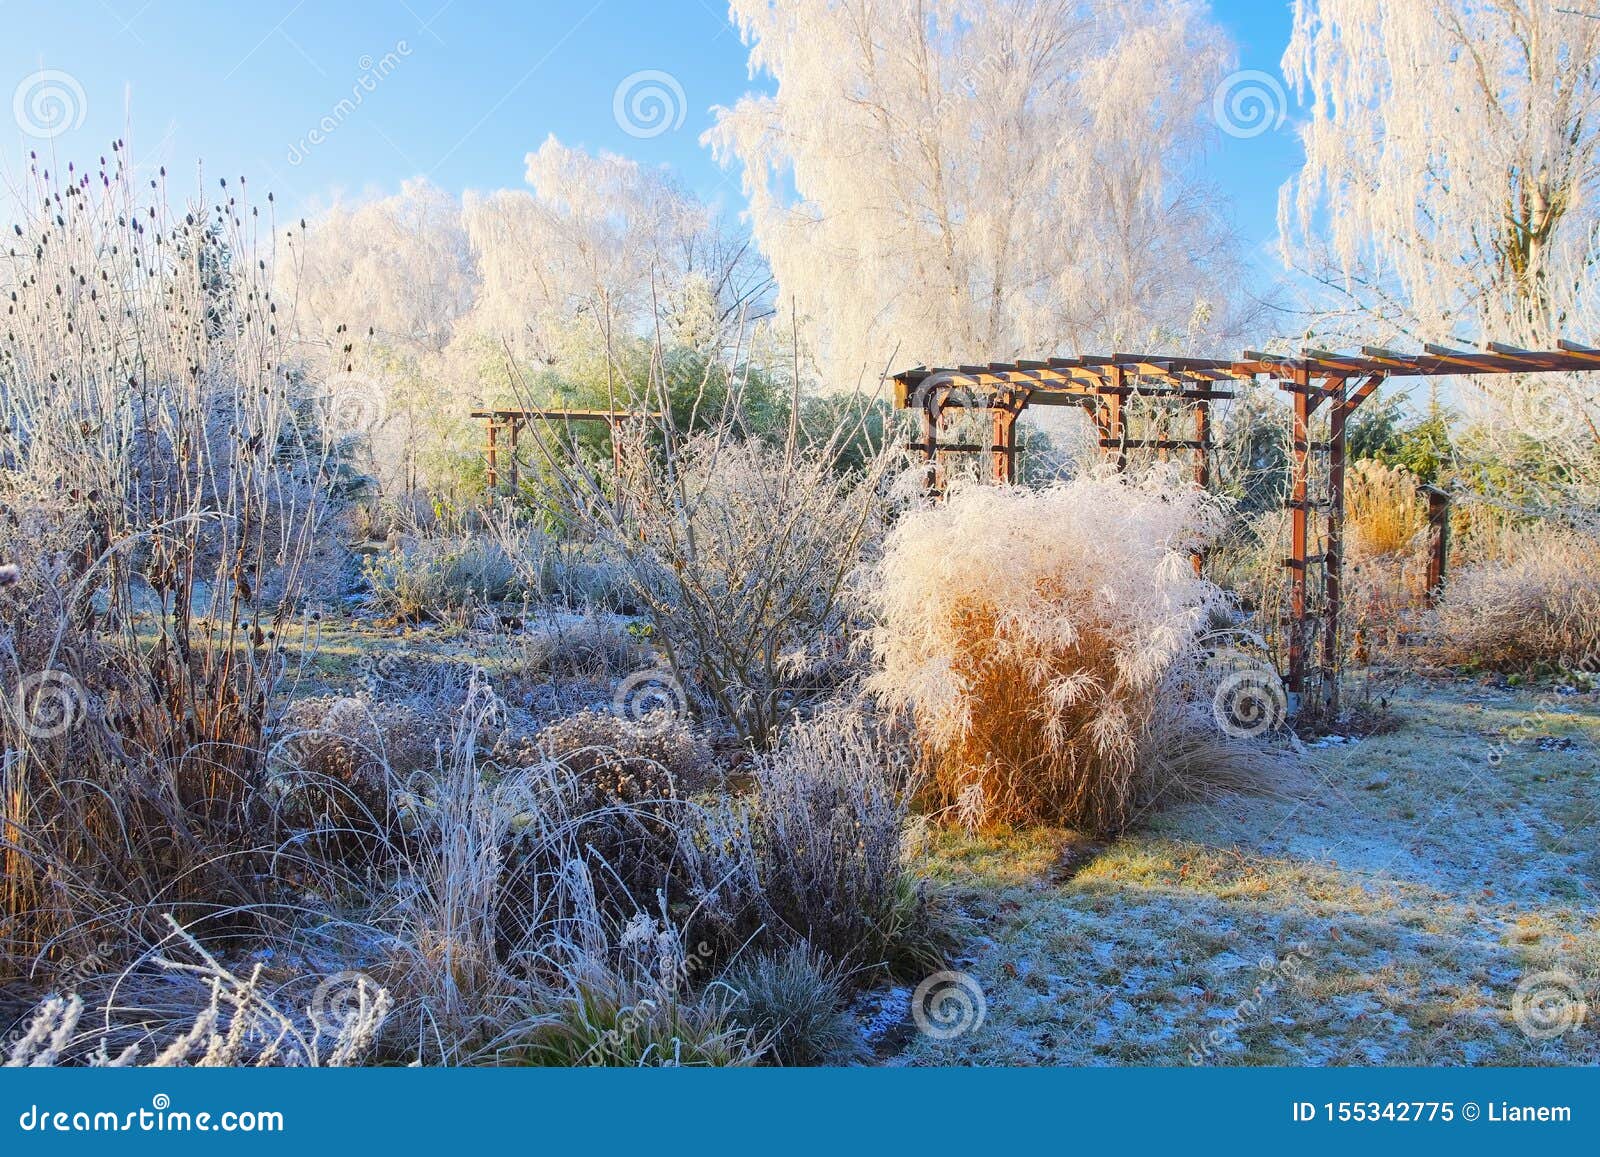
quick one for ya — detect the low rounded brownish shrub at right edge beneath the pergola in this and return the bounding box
[1437,526,1600,672]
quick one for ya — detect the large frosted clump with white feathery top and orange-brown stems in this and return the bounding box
[875,470,1222,829]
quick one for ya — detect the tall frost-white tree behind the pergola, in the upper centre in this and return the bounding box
[706,0,1227,387]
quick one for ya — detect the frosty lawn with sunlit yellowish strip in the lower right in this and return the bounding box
[891,683,1600,1064]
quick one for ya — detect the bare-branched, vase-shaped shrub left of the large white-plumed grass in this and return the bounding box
[544,429,888,746]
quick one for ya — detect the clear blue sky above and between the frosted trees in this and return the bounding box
[0,0,1299,264]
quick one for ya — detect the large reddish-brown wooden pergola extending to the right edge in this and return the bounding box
[893,342,1600,715]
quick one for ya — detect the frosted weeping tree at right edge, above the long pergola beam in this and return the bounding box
[1280,0,1600,346]
